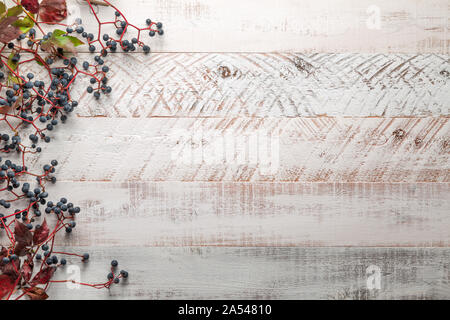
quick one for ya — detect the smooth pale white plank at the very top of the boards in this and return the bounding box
[62,0,450,53]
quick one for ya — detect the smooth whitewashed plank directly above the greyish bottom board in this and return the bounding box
[22,182,450,247]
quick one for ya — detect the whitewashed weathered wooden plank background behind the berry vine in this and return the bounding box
[9,0,450,299]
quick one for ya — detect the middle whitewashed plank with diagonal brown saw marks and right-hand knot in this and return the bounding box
[30,117,450,182]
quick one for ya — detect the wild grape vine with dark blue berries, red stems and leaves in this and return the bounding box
[0,0,163,299]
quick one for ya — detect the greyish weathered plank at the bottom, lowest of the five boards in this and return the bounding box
[44,246,450,300]
